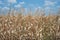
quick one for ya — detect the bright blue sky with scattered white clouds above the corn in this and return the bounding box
[0,0,60,14]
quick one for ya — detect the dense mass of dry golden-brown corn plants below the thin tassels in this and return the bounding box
[0,14,60,40]
